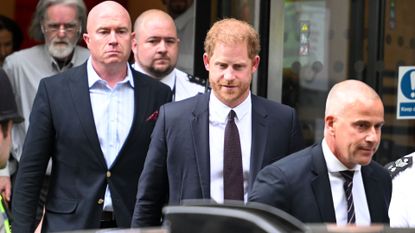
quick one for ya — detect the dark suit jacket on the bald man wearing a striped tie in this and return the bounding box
[249,143,392,223]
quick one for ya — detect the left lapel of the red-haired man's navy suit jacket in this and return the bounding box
[191,93,210,199]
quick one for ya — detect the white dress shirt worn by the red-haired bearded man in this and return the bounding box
[209,92,252,203]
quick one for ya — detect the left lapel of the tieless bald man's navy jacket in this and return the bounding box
[68,63,107,167]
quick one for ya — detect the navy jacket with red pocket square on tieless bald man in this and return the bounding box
[13,63,171,232]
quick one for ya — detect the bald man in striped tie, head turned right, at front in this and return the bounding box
[249,80,392,225]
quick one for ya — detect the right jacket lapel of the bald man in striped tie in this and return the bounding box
[362,165,384,222]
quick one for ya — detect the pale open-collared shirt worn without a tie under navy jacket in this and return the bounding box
[87,59,134,211]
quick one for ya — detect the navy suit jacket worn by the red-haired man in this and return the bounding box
[132,93,303,227]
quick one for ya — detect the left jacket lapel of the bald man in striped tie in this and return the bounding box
[311,144,336,222]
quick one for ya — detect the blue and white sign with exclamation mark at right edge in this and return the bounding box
[396,66,415,119]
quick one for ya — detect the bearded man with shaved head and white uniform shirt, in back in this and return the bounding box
[132,9,206,101]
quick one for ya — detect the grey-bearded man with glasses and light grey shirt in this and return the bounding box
[0,0,89,228]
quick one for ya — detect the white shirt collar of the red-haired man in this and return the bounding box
[209,91,252,123]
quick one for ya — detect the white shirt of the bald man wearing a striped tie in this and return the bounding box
[322,139,371,226]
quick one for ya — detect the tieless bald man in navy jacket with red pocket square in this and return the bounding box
[12,1,171,232]
